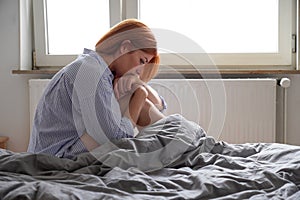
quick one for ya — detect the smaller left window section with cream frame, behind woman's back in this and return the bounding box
[33,0,121,67]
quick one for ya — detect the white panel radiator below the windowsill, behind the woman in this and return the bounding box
[29,78,277,143]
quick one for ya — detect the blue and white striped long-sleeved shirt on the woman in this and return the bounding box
[28,49,134,157]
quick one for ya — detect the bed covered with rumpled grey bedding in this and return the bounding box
[0,114,300,200]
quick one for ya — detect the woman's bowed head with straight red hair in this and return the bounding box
[96,19,159,82]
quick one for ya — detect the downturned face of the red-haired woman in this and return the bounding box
[114,50,153,78]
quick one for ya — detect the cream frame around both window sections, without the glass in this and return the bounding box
[31,0,299,70]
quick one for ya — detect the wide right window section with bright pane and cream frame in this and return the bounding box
[139,0,296,68]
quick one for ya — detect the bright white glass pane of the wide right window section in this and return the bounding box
[139,0,279,53]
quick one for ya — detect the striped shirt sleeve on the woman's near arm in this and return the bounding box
[74,56,134,144]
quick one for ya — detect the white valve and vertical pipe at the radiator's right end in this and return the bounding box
[277,78,291,144]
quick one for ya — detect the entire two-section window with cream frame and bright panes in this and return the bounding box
[34,0,296,69]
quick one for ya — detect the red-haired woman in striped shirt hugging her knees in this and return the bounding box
[28,19,165,158]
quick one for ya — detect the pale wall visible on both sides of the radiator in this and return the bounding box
[0,0,300,152]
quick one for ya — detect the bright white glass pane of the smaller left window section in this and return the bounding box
[46,0,110,55]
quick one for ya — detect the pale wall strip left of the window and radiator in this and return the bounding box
[0,0,49,152]
